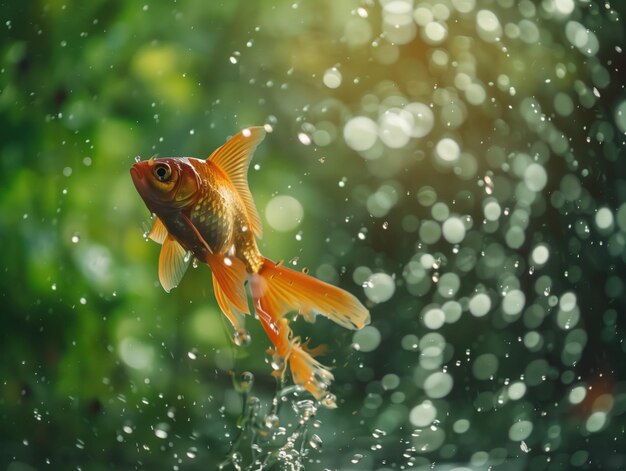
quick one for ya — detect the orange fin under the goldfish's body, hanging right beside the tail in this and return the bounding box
[207,254,250,318]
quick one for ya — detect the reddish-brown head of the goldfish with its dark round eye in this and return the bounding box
[130,157,200,211]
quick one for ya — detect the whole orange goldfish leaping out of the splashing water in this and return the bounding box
[130,127,370,406]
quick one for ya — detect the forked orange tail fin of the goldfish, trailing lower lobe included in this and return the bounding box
[251,259,369,407]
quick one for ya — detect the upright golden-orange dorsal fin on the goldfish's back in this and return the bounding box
[208,126,265,237]
